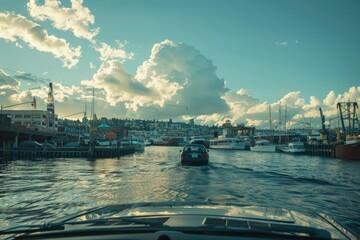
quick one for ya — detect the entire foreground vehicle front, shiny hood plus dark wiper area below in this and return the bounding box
[0,201,358,239]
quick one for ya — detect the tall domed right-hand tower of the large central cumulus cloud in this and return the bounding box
[135,40,229,116]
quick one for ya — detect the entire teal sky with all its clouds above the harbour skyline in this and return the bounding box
[0,0,360,128]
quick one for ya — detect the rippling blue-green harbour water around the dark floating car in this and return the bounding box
[0,146,360,233]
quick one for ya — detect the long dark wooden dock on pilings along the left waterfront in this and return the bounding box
[0,147,135,160]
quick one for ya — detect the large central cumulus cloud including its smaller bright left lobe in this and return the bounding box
[82,40,229,119]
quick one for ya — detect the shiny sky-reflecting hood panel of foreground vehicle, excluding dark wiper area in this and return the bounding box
[58,202,358,239]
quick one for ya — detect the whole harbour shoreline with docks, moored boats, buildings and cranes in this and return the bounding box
[0,83,360,160]
